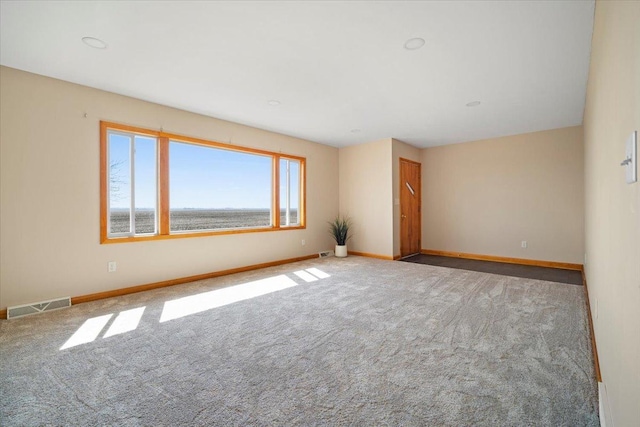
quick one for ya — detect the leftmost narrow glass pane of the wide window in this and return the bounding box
[109,133,131,233]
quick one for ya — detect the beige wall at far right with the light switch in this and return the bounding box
[584,1,640,427]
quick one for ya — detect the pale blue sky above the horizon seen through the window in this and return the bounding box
[109,134,299,209]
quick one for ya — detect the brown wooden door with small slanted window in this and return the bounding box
[400,159,422,257]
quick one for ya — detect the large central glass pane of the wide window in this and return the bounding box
[169,141,271,232]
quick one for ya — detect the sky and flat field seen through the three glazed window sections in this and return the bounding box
[107,130,302,236]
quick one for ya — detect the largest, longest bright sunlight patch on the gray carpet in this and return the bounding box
[160,274,298,323]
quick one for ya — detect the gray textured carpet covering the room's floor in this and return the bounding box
[0,257,599,426]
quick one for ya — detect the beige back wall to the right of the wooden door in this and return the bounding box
[422,126,584,264]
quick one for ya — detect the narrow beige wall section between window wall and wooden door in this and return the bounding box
[339,138,393,257]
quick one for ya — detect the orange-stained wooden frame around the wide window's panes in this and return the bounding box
[100,121,307,244]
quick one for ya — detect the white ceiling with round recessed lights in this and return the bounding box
[0,0,595,147]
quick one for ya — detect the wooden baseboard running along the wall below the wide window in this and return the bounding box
[0,255,318,319]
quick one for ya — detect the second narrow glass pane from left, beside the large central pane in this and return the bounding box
[134,136,157,234]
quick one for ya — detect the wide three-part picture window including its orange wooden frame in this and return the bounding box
[100,122,305,243]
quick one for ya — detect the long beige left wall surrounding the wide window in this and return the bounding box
[0,67,340,308]
